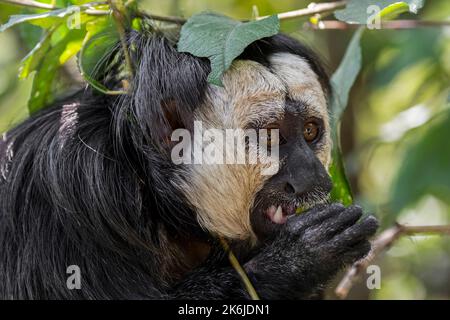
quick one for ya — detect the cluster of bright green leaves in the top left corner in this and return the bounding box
[0,0,128,114]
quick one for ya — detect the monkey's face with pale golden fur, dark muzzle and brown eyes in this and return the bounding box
[177,53,331,240]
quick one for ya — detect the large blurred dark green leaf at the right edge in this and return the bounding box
[387,108,450,220]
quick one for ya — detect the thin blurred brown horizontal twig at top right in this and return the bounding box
[306,20,450,30]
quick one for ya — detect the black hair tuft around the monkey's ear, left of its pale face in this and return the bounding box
[126,33,210,143]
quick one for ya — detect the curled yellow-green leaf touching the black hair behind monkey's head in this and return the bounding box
[78,17,120,94]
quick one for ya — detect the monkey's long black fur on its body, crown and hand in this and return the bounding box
[0,33,376,299]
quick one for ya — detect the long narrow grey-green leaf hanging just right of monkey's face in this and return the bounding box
[330,28,364,205]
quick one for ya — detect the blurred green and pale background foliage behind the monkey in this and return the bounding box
[0,0,450,299]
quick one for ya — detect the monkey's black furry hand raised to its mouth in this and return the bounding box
[244,203,378,299]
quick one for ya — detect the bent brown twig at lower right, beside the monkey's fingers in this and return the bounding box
[334,224,450,299]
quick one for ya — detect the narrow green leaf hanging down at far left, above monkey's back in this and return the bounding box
[28,26,85,114]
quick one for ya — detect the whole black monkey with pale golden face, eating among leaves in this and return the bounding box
[0,31,378,299]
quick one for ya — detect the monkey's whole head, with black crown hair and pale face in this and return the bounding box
[121,31,331,240]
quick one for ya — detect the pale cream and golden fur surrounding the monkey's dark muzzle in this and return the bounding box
[173,53,331,239]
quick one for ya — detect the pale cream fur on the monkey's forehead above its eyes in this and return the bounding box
[203,52,327,126]
